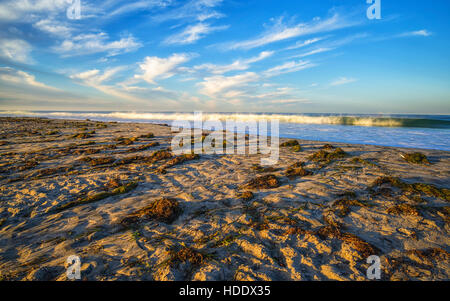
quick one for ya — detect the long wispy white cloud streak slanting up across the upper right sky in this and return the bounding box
[226,13,357,49]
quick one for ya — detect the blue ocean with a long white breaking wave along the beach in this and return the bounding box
[0,111,450,151]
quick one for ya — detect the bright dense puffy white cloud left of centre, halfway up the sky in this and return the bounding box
[135,53,190,84]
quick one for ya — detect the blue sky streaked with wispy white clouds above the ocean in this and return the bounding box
[0,0,450,114]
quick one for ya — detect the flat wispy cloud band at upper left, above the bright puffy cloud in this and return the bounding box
[53,32,142,57]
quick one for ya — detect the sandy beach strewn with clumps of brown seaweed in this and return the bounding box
[0,117,450,281]
